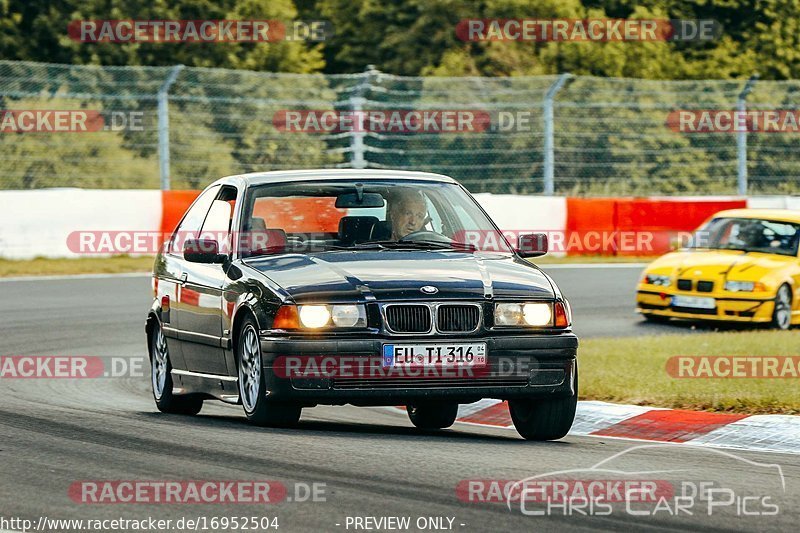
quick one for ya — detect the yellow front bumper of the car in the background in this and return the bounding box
[636,287,775,323]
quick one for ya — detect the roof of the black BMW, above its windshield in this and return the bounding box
[212,168,457,186]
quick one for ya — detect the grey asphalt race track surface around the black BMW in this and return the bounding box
[0,267,800,532]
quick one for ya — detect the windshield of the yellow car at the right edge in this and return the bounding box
[693,218,800,256]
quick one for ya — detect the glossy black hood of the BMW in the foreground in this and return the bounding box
[246,250,554,303]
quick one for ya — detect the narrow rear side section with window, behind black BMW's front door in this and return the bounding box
[157,185,220,370]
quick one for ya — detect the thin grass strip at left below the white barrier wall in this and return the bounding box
[0,255,154,278]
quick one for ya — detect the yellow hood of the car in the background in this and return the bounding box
[647,250,796,281]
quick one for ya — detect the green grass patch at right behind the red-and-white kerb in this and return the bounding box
[578,331,800,414]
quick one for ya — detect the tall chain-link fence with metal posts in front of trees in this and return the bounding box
[0,61,800,195]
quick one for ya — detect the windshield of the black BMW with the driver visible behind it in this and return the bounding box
[239,179,511,256]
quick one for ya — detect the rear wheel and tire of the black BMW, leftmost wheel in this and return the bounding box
[150,323,203,415]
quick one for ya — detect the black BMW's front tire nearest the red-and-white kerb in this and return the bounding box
[508,368,578,441]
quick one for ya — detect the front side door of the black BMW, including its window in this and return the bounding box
[178,186,236,376]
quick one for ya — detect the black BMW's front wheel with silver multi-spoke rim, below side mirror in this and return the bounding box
[236,317,303,427]
